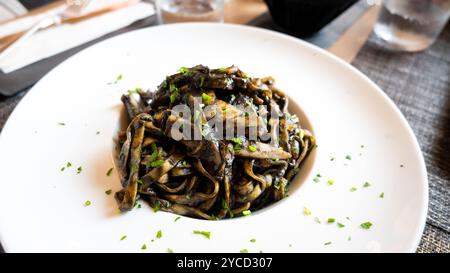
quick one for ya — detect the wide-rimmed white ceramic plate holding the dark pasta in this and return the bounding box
[0,24,428,252]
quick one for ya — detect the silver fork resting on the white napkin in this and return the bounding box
[0,0,91,60]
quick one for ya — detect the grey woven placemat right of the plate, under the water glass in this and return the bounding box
[353,25,450,253]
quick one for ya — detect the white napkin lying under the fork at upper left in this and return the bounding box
[0,0,155,73]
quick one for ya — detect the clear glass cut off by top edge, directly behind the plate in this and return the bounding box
[154,0,224,24]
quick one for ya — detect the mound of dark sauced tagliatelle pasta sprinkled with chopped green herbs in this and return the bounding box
[115,65,315,220]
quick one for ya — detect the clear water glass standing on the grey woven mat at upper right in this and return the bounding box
[374,0,450,51]
